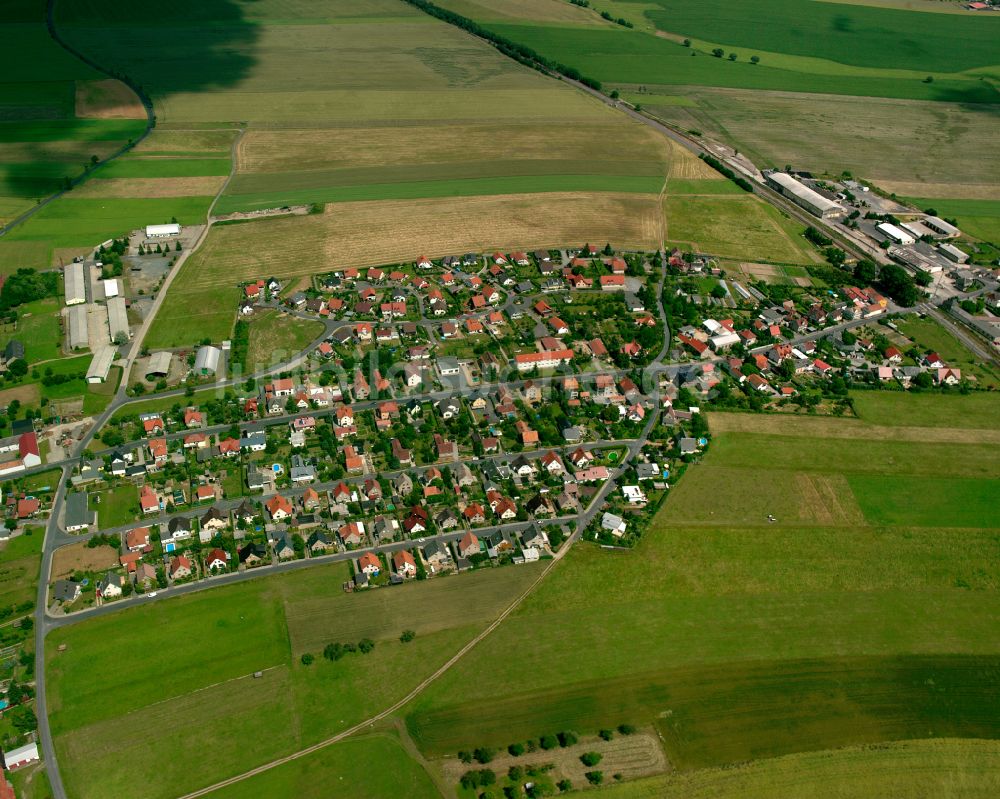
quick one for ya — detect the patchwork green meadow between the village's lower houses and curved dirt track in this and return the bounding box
[47,564,538,799]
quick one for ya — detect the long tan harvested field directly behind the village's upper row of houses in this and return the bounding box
[181,193,660,288]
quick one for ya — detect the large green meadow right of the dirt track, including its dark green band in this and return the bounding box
[406,406,1000,769]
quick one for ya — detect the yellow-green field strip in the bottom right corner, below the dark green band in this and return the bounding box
[597,739,1000,799]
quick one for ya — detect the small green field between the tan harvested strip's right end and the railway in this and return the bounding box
[664,194,815,264]
